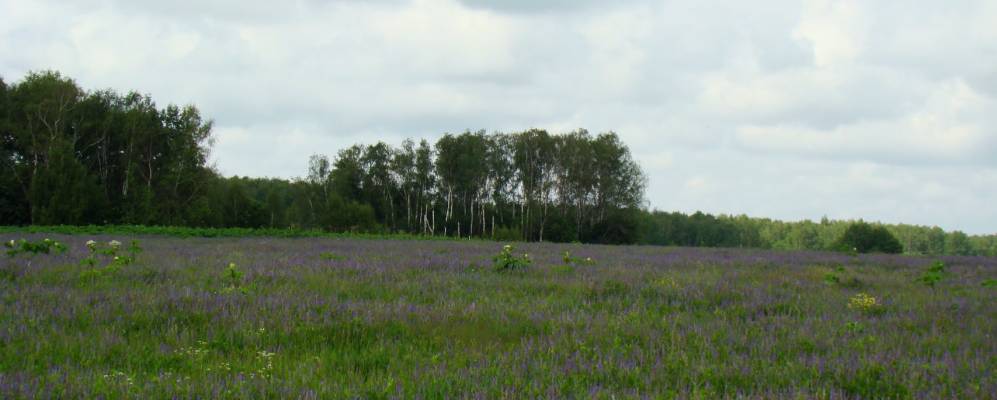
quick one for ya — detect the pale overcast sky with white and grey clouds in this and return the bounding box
[0,0,997,234]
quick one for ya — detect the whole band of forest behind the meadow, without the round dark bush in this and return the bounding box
[0,71,997,256]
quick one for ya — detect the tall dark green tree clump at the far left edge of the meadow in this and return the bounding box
[0,71,213,225]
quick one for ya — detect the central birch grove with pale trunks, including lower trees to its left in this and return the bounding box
[207,129,646,243]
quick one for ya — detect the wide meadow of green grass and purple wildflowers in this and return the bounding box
[0,234,997,399]
